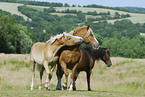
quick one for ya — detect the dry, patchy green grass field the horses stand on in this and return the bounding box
[0,54,145,97]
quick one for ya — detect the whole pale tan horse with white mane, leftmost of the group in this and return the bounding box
[30,33,83,90]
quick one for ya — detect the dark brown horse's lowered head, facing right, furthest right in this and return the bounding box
[101,49,112,67]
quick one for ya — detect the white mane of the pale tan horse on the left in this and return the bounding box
[46,32,72,44]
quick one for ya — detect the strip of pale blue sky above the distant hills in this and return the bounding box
[35,0,145,8]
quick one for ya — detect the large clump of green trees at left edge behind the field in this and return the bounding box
[0,14,32,53]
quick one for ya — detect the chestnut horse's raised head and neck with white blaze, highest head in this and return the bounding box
[70,24,99,49]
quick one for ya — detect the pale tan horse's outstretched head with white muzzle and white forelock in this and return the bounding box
[61,32,84,46]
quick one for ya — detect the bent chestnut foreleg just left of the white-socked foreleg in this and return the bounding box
[60,61,69,90]
